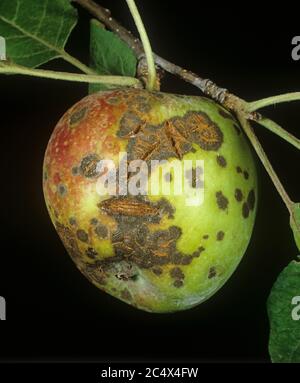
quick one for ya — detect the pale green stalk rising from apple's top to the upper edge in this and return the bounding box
[126,0,157,90]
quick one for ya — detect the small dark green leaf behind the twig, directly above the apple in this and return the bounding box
[89,19,137,93]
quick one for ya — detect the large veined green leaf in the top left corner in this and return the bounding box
[0,0,77,68]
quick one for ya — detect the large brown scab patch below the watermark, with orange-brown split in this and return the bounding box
[98,196,205,276]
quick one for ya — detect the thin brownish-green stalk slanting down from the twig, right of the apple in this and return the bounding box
[237,113,294,215]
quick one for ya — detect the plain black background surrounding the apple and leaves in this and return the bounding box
[0,0,300,361]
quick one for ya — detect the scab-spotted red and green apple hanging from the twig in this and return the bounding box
[43,88,257,313]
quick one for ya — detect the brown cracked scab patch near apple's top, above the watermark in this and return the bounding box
[117,110,223,166]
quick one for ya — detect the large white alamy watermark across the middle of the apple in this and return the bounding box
[94,152,204,206]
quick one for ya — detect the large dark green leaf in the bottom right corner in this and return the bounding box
[268,261,300,362]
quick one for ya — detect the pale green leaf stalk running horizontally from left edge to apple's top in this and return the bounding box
[0,61,142,88]
